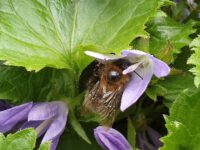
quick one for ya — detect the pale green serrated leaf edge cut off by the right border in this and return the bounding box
[187,35,200,87]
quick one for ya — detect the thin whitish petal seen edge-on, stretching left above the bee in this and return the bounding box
[85,51,125,63]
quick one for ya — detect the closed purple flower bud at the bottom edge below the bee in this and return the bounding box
[94,126,132,150]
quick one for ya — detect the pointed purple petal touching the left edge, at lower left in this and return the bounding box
[0,103,32,133]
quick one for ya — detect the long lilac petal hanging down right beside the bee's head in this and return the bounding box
[120,62,153,111]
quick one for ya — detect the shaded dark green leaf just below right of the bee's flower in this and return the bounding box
[146,71,198,107]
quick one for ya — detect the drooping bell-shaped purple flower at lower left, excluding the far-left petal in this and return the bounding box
[22,101,68,150]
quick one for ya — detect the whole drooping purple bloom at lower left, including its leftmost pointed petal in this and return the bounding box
[0,101,68,150]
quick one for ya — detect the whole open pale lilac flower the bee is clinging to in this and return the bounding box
[85,50,170,111]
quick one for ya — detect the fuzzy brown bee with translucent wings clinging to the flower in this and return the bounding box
[82,59,131,126]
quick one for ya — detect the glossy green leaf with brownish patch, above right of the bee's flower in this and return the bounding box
[147,17,195,56]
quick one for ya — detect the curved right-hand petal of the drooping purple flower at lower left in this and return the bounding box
[42,102,68,143]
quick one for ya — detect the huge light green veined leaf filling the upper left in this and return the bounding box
[0,0,162,71]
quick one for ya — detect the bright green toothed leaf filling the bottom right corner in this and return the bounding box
[162,91,200,150]
